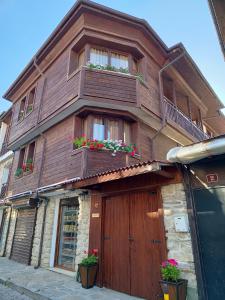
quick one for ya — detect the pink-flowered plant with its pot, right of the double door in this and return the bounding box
[160,259,187,300]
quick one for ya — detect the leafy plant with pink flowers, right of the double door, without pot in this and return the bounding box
[161,259,181,282]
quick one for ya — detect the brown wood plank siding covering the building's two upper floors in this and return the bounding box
[6,1,222,194]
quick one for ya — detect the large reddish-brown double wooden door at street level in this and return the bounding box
[103,191,165,300]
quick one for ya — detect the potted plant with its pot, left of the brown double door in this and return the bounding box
[78,249,98,289]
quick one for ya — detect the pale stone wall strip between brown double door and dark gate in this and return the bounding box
[161,183,198,300]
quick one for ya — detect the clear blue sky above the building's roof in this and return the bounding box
[0,0,225,112]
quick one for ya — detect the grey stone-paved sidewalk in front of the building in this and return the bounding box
[0,257,140,300]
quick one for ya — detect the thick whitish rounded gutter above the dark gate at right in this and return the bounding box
[167,135,225,164]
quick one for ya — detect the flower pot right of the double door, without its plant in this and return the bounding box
[160,279,188,300]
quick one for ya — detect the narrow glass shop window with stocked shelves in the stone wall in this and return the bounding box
[55,198,79,271]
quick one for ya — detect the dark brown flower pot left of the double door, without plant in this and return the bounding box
[78,264,98,289]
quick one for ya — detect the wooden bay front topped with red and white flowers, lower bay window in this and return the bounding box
[73,137,140,177]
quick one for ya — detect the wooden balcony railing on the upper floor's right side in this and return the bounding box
[163,97,209,141]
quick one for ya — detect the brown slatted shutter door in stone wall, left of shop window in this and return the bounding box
[10,208,36,265]
